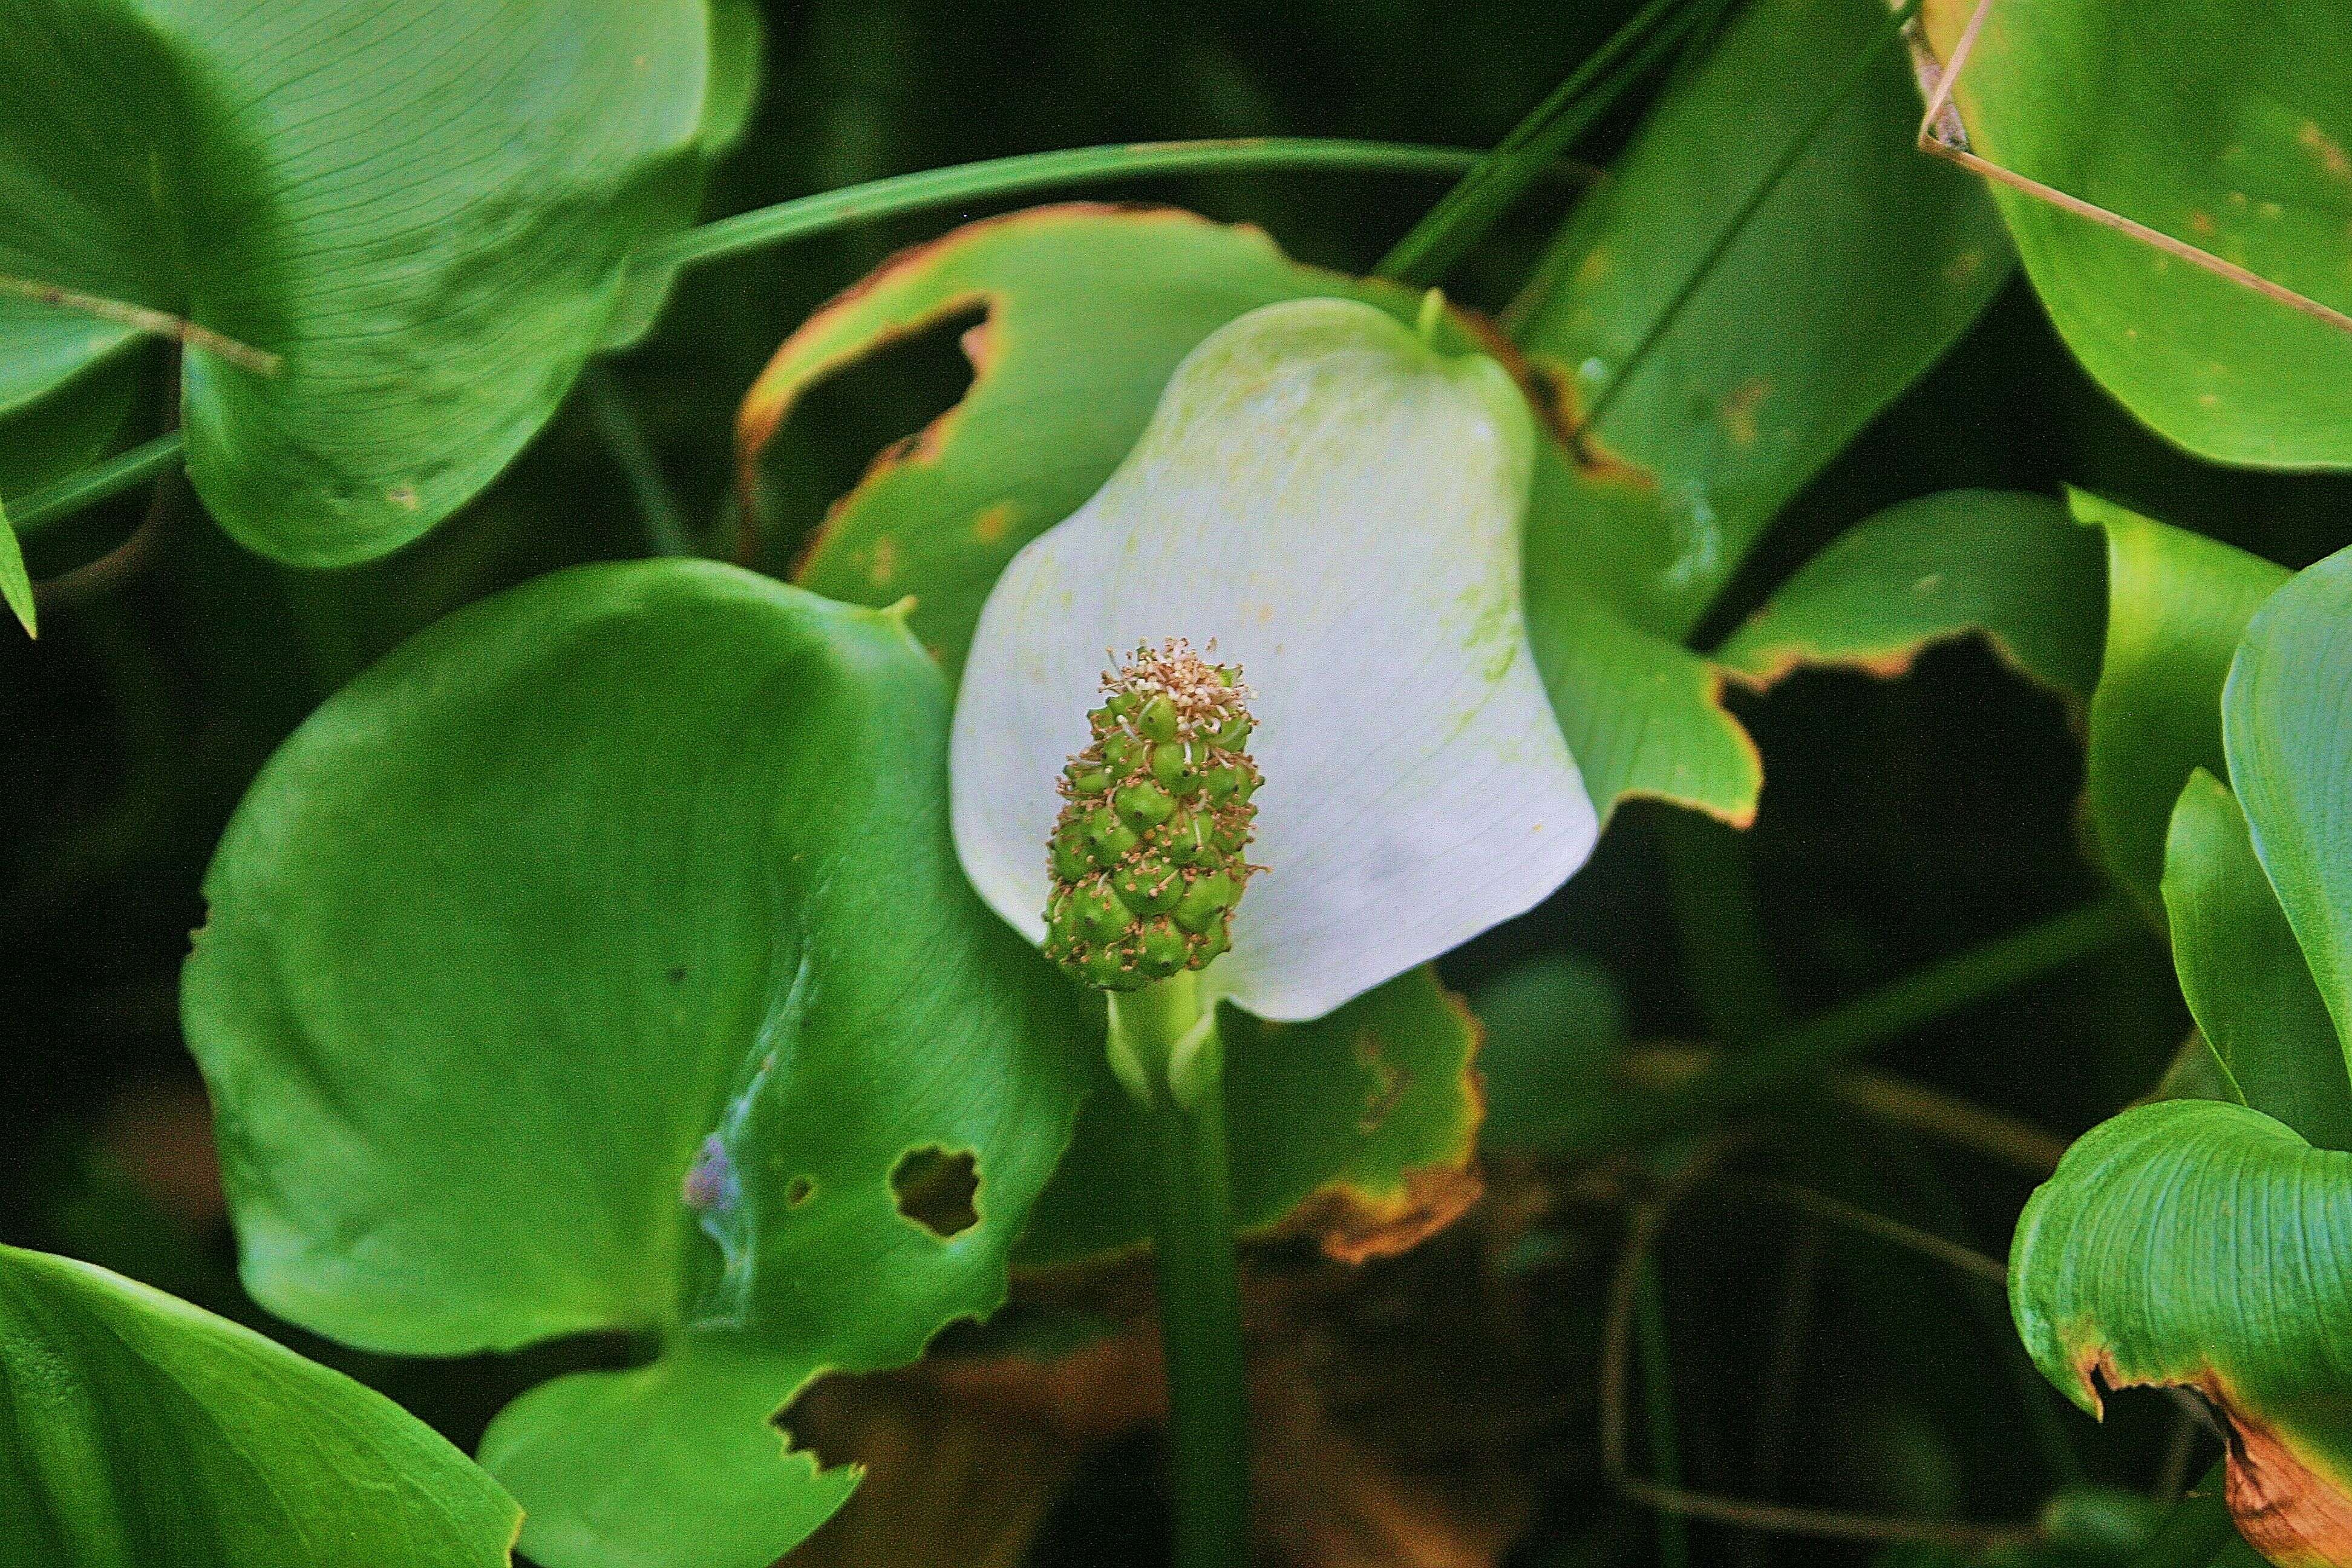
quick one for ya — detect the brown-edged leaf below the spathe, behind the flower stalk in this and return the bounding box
[1021,969,1484,1265]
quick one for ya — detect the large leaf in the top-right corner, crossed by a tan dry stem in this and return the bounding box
[1924,0,2352,468]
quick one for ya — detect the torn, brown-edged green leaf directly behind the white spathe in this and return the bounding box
[739,204,1762,818]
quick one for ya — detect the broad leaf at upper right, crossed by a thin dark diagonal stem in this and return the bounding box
[1512,0,2008,637]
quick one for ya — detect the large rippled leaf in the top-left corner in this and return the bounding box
[0,0,741,567]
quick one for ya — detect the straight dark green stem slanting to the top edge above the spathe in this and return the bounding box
[1374,0,1696,282]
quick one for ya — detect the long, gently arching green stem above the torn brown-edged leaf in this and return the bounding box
[633,136,1480,266]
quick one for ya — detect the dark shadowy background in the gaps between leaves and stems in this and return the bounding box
[0,0,2352,1563]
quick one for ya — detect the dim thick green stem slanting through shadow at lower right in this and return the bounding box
[1562,893,2148,1147]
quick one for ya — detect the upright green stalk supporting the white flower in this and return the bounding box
[1110,971,1249,1568]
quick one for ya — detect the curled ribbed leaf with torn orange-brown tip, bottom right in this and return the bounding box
[2008,1100,2352,1568]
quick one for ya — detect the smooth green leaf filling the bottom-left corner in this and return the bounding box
[0,1246,520,1568]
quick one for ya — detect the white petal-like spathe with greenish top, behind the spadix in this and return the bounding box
[950,299,1599,1021]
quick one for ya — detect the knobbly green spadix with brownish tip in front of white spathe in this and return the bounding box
[1044,637,1263,990]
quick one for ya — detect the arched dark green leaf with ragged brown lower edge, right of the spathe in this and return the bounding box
[1714,489,2105,703]
